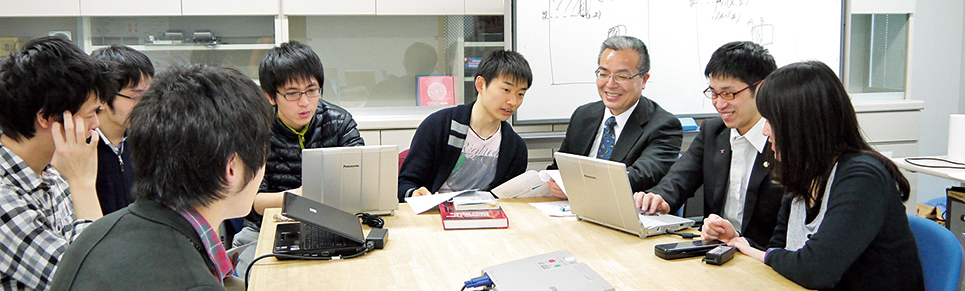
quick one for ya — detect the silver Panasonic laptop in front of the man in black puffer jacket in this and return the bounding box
[302,145,399,215]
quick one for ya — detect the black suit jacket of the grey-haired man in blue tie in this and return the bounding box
[546,96,683,192]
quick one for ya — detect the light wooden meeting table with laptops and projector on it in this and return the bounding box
[250,198,802,290]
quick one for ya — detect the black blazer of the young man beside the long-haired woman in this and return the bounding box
[647,117,784,248]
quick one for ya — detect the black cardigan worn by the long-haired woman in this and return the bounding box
[764,154,925,290]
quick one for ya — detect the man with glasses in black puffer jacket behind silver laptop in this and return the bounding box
[233,41,365,278]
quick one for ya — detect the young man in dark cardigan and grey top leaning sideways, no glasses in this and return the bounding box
[399,50,533,202]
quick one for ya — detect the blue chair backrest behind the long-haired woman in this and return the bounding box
[908,215,962,291]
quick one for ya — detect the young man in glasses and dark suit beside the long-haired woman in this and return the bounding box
[634,41,784,244]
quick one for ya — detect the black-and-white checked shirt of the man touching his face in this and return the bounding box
[0,145,93,290]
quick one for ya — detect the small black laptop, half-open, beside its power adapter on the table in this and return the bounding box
[272,192,365,257]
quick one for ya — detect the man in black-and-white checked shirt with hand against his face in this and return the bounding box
[0,37,117,290]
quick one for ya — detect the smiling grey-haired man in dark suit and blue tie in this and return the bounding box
[547,36,683,198]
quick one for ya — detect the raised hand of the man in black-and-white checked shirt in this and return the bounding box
[50,111,104,219]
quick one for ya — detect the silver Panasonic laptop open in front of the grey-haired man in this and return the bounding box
[554,152,694,238]
